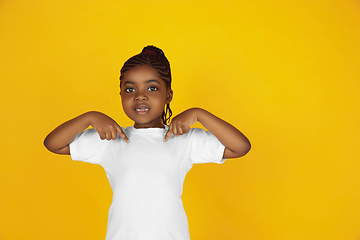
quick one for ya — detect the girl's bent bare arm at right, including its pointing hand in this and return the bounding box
[164,108,251,159]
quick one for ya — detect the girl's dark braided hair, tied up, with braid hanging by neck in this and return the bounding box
[120,45,172,124]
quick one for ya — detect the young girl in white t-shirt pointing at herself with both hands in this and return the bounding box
[44,46,250,240]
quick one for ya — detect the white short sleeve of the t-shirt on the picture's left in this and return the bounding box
[69,129,108,164]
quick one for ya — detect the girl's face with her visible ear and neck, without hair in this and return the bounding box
[120,65,173,128]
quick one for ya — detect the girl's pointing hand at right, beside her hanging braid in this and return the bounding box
[164,108,198,142]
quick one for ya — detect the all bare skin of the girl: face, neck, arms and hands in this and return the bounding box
[44,65,251,159]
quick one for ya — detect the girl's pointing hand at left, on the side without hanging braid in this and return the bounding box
[87,111,130,143]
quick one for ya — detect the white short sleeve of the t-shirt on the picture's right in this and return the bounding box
[189,128,225,164]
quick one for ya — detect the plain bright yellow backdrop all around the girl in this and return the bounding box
[0,0,360,240]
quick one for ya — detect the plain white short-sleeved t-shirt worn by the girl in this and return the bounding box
[70,126,225,240]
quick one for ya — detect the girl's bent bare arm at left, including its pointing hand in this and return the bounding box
[44,111,129,155]
